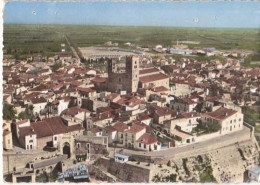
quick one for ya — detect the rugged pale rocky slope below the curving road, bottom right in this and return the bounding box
[150,139,259,183]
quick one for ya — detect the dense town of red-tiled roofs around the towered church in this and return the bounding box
[3,37,260,182]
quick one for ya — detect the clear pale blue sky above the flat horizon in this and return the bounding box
[4,1,260,28]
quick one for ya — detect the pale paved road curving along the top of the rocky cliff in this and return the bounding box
[122,127,250,158]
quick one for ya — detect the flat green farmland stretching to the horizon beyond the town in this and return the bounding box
[4,24,260,58]
